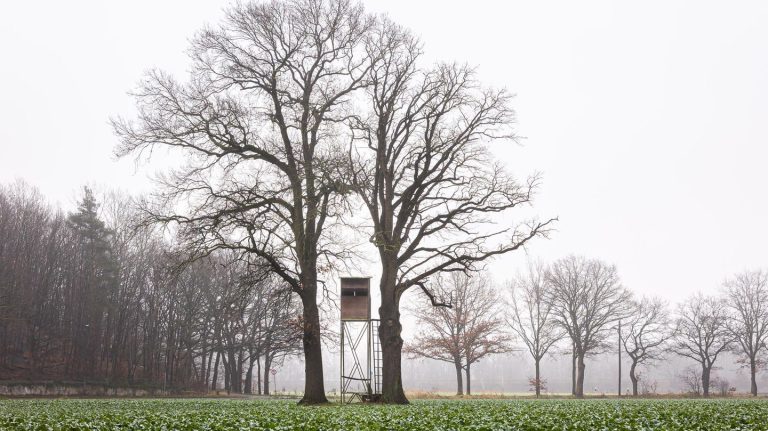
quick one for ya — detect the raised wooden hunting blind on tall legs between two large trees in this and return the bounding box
[339,277,381,403]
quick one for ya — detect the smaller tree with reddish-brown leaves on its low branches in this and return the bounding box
[405,273,511,395]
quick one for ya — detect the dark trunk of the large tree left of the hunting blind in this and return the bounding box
[296,277,328,404]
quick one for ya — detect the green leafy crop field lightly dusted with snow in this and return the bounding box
[0,399,768,431]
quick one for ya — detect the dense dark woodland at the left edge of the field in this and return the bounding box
[0,183,301,393]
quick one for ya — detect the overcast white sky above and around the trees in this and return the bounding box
[0,0,768,301]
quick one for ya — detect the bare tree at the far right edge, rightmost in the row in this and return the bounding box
[724,271,768,396]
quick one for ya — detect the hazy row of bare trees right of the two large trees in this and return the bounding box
[406,256,768,397]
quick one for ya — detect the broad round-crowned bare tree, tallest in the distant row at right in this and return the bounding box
[547,256,631,397]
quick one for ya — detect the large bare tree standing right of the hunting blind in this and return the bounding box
[349,19,552,403]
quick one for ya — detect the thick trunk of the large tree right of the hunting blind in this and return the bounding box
[379,260,408,404]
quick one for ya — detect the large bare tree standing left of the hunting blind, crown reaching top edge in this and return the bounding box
[114,0,371,403]
